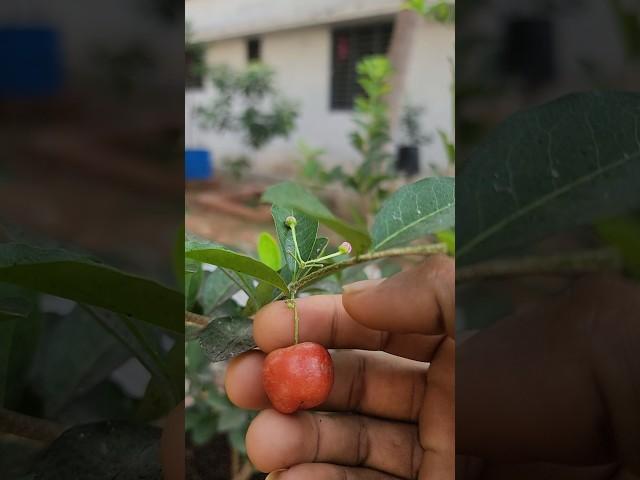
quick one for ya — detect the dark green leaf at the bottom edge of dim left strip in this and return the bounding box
[33,421,162,480]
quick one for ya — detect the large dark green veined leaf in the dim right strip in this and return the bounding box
[456,92,640,263]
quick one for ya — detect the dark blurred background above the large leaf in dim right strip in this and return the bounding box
[456,0,640,161]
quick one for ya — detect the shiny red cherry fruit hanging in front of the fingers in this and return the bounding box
[262,342,333,413]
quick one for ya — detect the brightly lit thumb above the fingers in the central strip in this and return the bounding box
[342,255,455,337]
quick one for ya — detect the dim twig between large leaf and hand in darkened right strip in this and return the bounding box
[456,248,622,283]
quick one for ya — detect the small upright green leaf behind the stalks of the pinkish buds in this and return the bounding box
[271,205,318,282]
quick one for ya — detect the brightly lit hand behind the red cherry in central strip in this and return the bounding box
[225,256,455,480]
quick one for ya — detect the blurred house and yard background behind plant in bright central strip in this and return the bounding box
[184,0,455,480]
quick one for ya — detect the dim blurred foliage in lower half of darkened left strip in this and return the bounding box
[0,230,184,480]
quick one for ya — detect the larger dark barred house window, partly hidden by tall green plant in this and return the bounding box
[331,22,393,110]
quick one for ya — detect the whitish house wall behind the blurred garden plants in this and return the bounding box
[186,18,454,178]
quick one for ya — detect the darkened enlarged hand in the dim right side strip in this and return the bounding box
[456,277,640,480]
